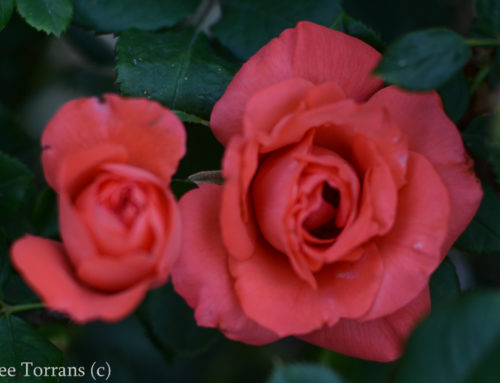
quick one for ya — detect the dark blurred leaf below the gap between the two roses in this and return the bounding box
[142,284,219,356]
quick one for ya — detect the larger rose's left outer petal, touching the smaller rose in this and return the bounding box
[172,184,279,345]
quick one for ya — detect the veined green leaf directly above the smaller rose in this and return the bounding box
[116,28,238,118]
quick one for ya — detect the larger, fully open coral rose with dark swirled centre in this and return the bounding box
[173,22,482,361]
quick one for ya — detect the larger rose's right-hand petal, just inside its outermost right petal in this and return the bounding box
[363,152,450,320]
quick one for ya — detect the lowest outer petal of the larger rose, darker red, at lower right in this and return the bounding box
[301,288,430,362]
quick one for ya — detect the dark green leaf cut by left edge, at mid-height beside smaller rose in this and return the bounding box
[0,152,32,223]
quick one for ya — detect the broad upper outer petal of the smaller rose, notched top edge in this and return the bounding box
[42,94,185,191]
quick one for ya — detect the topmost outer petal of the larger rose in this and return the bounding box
[210,21,382,145]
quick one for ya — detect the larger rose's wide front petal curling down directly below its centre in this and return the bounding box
[229,245,383,336]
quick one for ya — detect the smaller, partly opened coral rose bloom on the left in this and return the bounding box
[11,94,185,322]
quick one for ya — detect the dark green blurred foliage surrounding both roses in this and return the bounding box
[0,0,500,383]
